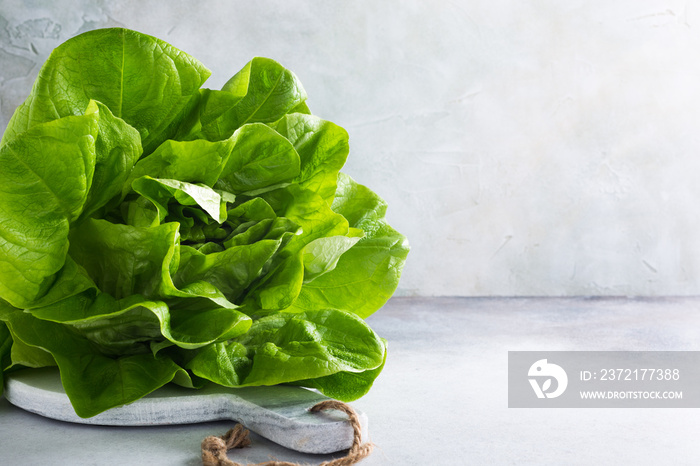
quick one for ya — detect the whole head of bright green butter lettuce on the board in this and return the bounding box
[0,28,409,417]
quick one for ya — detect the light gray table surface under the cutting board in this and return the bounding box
[0,298,700,466]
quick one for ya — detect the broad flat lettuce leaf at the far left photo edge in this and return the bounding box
[0,109,98,307]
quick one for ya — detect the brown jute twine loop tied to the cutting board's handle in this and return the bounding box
[202,400,374,466]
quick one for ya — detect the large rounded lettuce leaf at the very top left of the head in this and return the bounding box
[2,28,211,154]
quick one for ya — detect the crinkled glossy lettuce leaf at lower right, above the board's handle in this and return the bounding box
[186,310,385,399]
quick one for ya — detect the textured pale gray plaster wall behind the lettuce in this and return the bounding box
[0,0,700,295]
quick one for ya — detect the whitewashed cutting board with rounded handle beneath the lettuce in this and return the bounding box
[4,368,367,454]
